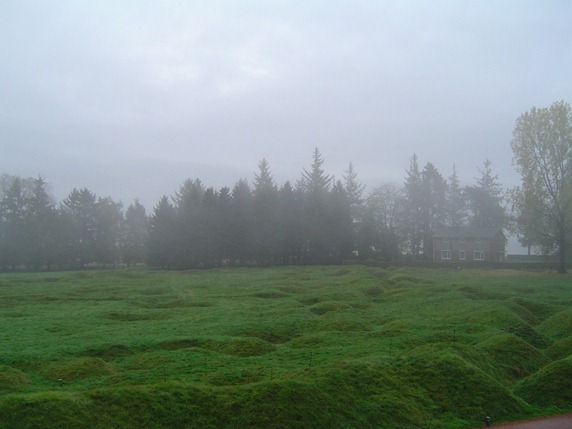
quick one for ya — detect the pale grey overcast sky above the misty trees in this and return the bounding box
[0,0,572,212]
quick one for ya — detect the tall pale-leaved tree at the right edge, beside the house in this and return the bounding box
[511,101,572,273]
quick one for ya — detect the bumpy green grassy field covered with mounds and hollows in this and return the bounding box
[0,266,572,429]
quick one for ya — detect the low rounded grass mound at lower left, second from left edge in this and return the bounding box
[41,357,117,382]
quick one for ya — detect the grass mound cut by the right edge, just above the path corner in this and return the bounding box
[515,358,572,409]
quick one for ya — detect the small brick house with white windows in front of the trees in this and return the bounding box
[433,227,507,263]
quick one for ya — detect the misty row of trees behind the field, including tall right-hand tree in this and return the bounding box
[0,102,572,271]
